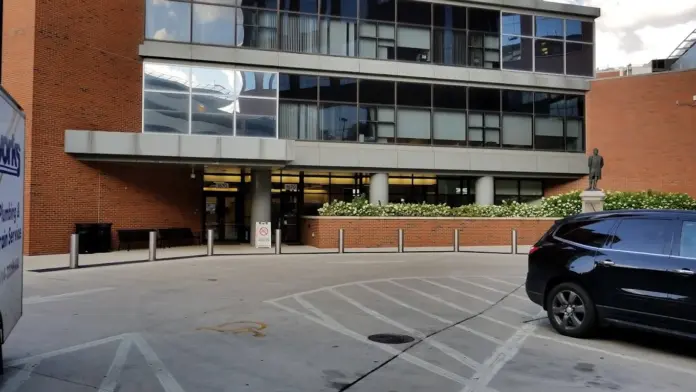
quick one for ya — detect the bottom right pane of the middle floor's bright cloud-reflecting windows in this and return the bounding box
[235,98,277,137]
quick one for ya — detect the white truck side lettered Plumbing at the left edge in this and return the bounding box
[0,86,25,374]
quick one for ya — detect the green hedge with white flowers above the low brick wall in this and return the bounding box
[319,191,696,218]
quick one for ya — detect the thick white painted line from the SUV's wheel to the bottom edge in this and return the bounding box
[462,311,544,392]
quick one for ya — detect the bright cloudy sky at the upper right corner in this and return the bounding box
[547,0,696,69]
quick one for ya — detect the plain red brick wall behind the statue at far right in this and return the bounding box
[546,70,696,197]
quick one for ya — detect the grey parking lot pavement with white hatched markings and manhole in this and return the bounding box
[0,253,696,392]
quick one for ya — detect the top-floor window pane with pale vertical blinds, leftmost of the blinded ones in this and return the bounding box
[280,13,319,53]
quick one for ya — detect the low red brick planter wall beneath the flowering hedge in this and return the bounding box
[301,217,554,248]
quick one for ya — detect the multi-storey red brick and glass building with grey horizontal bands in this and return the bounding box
[2,0,599,254]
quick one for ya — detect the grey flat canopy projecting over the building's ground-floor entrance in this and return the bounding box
[65,130,295,167]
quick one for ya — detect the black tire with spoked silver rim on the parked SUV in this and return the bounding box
[545,282,597,338]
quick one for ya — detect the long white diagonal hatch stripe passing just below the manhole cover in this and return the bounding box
[266,301,486,385]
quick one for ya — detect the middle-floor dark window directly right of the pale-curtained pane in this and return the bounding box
[319,103,358,142]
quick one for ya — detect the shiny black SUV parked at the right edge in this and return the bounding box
[526,210,696,338]
